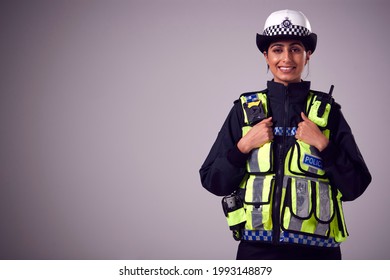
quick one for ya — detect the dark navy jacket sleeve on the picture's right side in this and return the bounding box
[321,104,372,201]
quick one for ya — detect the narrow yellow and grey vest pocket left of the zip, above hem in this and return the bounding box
[244,175,274,230]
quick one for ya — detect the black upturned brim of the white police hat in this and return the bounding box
[256,33,317,53]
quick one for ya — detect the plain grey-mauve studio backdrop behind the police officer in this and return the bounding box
[0,0,390,259]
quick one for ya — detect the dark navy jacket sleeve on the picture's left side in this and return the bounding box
[199,101,248,196]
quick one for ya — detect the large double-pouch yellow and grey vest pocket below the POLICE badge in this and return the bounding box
[282,178,335,237]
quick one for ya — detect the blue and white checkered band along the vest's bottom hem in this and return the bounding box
[242,230,340,247]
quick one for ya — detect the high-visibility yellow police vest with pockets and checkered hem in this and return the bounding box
[222,91,348,247]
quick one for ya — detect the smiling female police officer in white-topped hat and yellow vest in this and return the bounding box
[200,10,371,259]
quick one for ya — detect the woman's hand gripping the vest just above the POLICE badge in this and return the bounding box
[295,113,329,152]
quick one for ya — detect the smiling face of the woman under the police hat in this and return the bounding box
[264,40,311,86]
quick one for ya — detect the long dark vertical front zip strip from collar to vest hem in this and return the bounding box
[272,88,289,244]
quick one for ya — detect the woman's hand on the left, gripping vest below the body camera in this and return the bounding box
[237,117,274,154]
